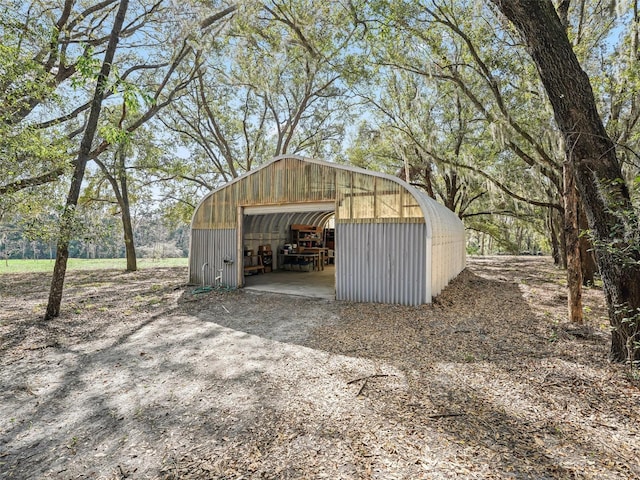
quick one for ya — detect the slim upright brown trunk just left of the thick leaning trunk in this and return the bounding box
[563,161,583,323]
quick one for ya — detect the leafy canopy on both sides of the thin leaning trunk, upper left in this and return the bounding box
[0,0,235,278]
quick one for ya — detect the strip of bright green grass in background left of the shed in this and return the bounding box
[0,258,189,275]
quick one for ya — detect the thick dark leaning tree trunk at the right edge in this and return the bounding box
[491,0,640,361]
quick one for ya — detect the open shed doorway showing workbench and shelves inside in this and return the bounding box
[242,202,336,299]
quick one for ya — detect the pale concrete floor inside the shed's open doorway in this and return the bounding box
[244,265,336,300]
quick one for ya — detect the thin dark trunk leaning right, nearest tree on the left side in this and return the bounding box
[44,0,129,320]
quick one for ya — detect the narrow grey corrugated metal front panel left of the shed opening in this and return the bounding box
[189,228,242,287]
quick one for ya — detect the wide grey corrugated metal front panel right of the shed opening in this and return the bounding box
[335,223,431,305]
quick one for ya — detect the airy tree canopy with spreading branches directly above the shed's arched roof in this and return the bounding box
[158,0,359,214]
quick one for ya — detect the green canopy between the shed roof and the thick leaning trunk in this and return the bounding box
[344,1,562,255]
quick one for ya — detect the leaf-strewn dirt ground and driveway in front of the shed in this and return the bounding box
[0,257,640,479]
